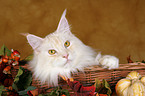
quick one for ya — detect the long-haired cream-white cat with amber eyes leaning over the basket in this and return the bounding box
[26,10,119,86]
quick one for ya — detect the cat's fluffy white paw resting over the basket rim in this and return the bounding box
[97,54,119,70]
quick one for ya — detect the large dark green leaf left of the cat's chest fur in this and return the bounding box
[14,67,32,91]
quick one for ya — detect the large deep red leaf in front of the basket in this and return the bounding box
[68,79,96,96]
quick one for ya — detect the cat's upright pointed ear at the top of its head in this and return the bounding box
[56,9,70,32]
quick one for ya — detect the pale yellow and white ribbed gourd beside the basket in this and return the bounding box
[115,71,145,96]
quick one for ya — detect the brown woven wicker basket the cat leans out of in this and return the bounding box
[19,62,145,96]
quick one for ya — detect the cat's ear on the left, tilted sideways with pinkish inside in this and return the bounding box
[25,34,43,51]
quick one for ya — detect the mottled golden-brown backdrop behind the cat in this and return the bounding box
[0,0,145,63]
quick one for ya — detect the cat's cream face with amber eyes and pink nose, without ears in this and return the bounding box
[37,32,82,68]
